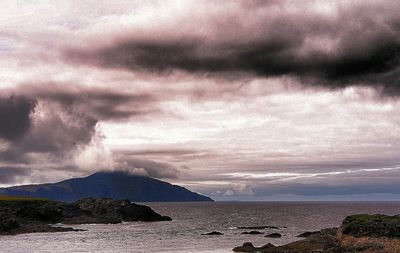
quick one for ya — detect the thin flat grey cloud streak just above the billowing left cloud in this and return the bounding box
[19,83,161,121]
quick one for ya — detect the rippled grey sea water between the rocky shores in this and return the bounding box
[0,202,400,253]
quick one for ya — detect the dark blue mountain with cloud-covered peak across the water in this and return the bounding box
[0,171,213,202]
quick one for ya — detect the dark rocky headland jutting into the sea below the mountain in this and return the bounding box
[0,198,171,235]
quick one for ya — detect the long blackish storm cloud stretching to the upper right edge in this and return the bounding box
[66,1,400,93]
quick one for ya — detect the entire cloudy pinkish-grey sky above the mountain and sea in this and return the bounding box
[0,0,400,201]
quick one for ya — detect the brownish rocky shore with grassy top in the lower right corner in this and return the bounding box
[233,214,400,253]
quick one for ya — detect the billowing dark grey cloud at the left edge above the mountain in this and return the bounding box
[0,89,98,165]
